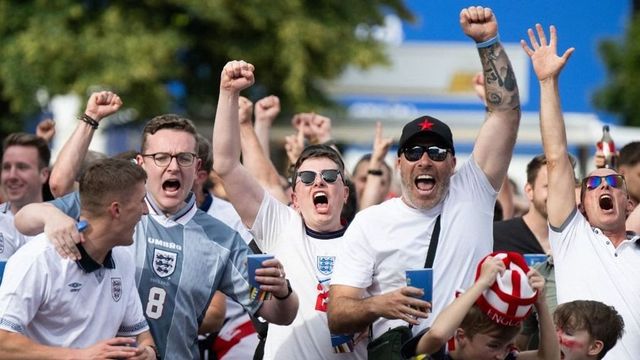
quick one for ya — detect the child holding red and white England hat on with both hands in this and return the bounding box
[402,252,560,360]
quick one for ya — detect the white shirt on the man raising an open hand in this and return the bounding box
[549,210,640,360]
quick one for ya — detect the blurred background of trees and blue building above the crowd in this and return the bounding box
[0,0,640,186]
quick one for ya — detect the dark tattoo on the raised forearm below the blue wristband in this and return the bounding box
[478,43,520,111]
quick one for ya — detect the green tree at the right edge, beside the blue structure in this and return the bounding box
[593,14,640,126]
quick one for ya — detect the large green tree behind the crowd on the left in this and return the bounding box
[0,0,412,138]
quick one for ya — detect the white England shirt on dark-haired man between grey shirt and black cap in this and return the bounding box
[251,192,366,360]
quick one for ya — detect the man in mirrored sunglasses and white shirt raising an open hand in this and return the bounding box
[522,24,640,360]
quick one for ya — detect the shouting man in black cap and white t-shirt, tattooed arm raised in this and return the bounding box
[329,7,520,348]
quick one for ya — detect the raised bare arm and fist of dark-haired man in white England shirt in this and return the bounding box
[212,61,264,228]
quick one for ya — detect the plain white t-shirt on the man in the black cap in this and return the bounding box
[331,158,497,338]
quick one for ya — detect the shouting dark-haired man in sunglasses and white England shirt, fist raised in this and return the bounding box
[212,61,366,359]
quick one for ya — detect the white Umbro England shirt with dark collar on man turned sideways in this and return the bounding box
[0,234,149,348]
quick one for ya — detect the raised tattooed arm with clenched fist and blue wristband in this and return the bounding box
[460,6,520,191]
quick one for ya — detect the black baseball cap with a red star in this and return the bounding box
[398,115,456,156]
